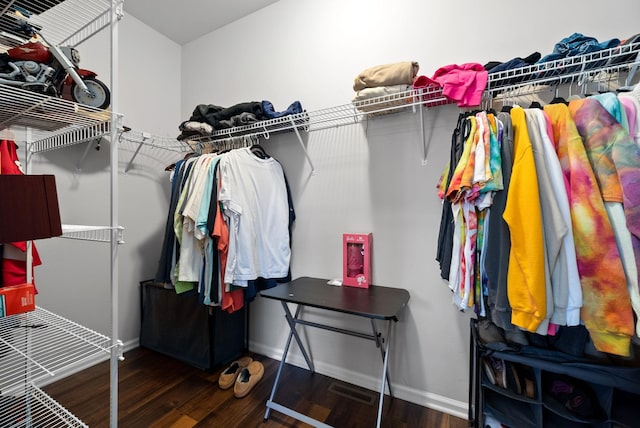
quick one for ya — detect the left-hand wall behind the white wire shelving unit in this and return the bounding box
[21,16,181,352]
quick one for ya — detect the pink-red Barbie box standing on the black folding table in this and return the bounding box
[342,233,373,288]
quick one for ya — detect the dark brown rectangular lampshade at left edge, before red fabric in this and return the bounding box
[0,174,62,244]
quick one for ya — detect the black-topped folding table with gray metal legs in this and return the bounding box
[260,277,409,428]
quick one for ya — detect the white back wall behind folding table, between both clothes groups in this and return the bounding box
[182,0,640,416]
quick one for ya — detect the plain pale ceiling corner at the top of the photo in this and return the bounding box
[124,0,278,45]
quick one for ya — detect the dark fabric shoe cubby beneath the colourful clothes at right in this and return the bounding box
[469,319,640,428]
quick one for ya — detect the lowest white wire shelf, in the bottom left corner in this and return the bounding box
[0,384,88,428]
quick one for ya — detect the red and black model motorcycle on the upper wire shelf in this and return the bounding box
[0,23,111,109]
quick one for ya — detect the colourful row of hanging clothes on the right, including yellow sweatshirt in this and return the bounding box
[438,91,640,356]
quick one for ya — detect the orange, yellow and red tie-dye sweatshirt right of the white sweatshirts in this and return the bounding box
[544,104,633,356]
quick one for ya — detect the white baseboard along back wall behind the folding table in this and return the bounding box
[249,341,469,419]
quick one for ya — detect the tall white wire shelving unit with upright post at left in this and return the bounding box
[0,0,123,427]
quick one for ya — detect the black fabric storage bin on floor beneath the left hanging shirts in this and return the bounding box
[140,280,246,370]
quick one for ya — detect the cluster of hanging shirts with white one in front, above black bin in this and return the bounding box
[156,148,295,312]
